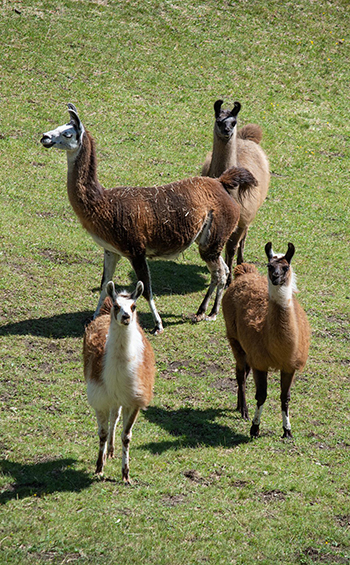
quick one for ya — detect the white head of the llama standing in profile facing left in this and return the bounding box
[40,103,85,151]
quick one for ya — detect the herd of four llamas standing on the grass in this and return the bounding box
[41,100,310,484]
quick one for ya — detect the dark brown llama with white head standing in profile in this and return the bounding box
[41,104,256,333]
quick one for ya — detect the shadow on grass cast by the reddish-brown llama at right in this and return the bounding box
[140,406,250,453]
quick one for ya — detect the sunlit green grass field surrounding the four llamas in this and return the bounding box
[0,0,350,565]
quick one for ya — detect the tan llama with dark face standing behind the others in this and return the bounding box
[202,100,270,285]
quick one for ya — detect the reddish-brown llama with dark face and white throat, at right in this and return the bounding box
[222,243,310,437]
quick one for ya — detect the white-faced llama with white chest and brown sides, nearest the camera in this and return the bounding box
[83,281,155,483]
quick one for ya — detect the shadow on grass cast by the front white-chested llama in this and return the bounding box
[0,459,94,504]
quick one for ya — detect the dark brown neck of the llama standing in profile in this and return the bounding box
[67,131,104,221]
